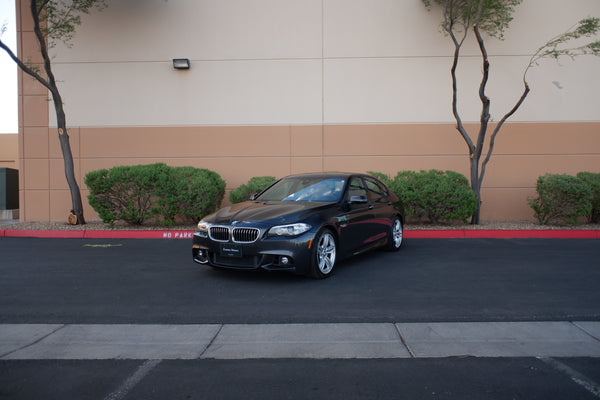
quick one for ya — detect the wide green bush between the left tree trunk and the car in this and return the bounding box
[85,163,225,226]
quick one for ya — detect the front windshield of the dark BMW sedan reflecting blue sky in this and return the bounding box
[256,176,346,203]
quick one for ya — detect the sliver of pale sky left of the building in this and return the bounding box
[0,0,19,134]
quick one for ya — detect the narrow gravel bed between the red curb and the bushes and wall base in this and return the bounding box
[0,220,600,231]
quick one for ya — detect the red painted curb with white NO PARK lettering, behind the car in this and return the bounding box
[0,229,600,239]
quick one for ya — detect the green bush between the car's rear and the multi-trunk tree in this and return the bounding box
[370,169,477,224]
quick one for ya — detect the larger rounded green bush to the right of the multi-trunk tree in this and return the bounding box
[529,174,592,225]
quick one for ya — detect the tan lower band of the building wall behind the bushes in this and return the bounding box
[17,123,600,220]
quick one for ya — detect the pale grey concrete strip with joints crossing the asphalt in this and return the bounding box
[0,321,600,360]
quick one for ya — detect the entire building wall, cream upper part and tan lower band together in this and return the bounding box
[17,0,600,220]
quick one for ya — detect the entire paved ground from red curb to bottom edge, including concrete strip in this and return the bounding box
[0,238,600,399]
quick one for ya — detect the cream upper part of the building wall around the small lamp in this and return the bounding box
[49,0,600,127]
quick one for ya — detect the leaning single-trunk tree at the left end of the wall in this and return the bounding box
[0,0,106,224]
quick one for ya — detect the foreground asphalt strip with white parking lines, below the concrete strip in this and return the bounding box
[0,357,599,400]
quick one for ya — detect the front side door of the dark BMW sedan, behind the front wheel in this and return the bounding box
[339,176,377,254]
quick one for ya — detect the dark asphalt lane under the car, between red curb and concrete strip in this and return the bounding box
[0,238,600,324]
